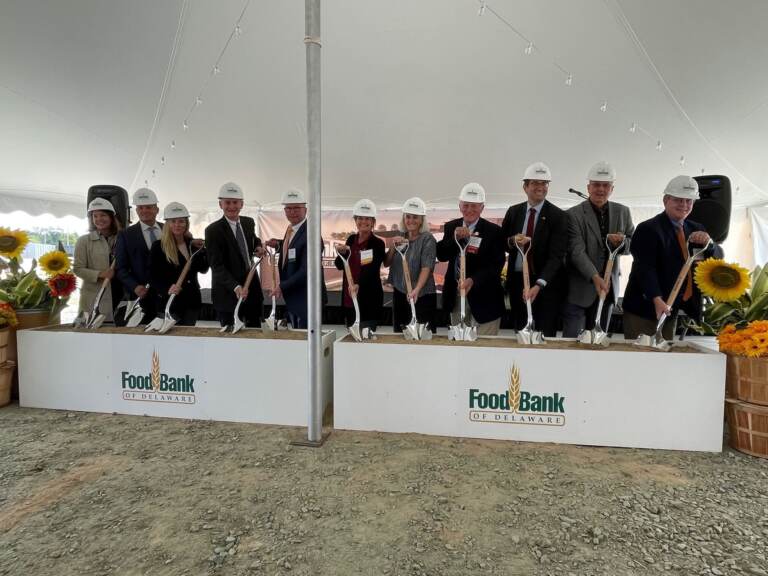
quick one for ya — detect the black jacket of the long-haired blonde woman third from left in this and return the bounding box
[149,240,209,313]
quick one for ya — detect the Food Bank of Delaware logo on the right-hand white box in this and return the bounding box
[469,364,565,426]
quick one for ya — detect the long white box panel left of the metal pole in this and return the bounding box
[18,328,334,426]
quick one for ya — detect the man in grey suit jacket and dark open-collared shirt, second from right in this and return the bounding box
[563,162,635,338]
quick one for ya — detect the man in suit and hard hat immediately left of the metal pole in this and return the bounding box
[268,189,307,328]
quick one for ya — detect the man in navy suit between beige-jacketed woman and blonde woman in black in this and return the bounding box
[115,188,163,324]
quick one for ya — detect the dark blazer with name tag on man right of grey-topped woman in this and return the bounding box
[437,218,504,324]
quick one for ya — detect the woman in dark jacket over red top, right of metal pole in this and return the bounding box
[335,200,386,331]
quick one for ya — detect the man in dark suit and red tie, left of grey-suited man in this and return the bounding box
[501,162,568,337]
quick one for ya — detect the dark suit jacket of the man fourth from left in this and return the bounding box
[205,216,264,316]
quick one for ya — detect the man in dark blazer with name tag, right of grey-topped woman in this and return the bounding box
[437,182,504,336]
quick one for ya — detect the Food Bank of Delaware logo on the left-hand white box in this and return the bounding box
[120,350,195,404]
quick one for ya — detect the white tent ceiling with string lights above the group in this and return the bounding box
[0,0,768,214]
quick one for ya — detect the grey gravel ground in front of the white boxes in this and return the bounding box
[0,406,768,576]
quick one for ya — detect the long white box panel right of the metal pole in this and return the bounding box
[334,336,725,452]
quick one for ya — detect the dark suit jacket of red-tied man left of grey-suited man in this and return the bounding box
[501,200,568,299]
